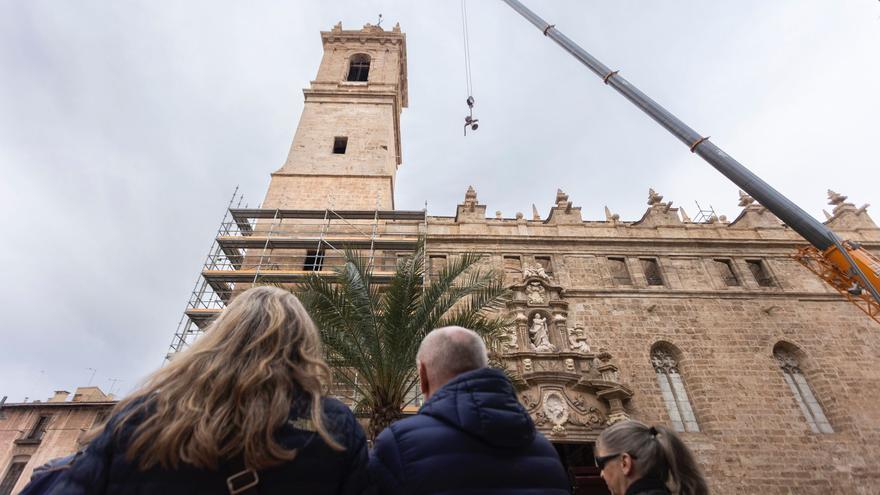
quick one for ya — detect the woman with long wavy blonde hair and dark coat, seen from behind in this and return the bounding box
[51,287,368,495]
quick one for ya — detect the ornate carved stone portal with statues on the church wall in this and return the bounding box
[496,272,632,442]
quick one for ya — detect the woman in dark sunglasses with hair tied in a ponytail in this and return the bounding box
[596,421,709,495]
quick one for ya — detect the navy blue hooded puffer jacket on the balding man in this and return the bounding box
[370,368,570,495]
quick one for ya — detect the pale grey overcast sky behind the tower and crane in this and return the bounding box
[0,0,880,402]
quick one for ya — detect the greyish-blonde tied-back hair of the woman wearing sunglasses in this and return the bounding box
[597,421,709,495]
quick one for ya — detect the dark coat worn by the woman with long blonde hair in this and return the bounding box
[50,397,369,495]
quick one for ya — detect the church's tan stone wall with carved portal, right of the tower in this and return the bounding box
[418,188,880,494]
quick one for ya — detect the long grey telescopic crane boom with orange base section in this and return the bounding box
[503,0,880,322]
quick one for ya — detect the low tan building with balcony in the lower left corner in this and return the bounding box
[0,387,116,495]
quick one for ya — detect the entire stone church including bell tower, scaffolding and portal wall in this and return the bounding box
[172,25,880,494]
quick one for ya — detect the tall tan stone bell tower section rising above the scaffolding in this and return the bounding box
[263,23,407,210]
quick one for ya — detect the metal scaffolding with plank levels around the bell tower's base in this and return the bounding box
[166,188,427,360]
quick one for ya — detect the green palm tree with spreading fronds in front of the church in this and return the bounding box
[297,242,510,438]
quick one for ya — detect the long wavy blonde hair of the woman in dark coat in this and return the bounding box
[114,287,343,470]
